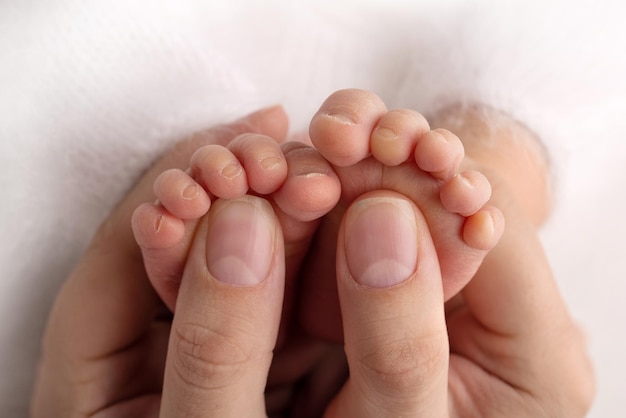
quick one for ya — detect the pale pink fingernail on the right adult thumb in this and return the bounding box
[345,197,418,288]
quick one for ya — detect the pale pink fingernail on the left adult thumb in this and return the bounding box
[207,196,274,286]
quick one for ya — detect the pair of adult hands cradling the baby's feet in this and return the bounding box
[33,102,592,417]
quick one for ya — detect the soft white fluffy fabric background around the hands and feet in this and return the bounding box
[0,0,626,418]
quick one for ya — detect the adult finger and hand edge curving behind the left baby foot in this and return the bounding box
[34,107,287,415]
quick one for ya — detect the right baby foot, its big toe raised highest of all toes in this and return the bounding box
[302,90,503,339]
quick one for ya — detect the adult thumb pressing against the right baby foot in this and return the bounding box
[328,192,449,418]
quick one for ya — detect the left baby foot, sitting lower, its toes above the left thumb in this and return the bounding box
[132,134,340,311]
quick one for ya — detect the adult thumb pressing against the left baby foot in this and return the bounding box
[161,196,285,418]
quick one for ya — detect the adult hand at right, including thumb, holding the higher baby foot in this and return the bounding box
[307,192,594,418]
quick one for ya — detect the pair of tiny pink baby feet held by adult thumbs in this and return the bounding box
[133,90,504,324]
